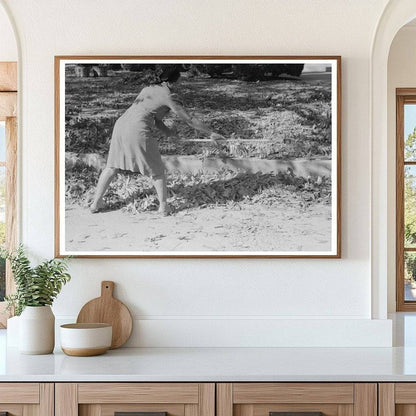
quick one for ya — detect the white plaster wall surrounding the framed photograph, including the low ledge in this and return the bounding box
[0,0,391,346]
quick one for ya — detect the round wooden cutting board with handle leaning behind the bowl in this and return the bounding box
[77,281,133,349]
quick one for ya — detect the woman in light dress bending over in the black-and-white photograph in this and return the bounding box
[90,65,223,215]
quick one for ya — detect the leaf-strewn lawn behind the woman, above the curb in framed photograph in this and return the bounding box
[65,71,332,159]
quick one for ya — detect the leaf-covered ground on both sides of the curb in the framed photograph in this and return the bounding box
[65,71,331,212]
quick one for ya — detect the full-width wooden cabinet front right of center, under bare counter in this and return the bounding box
[217,383,377,416]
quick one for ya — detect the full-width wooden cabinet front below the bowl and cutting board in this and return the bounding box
[55,383,215,416]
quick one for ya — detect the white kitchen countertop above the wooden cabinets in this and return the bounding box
[0,331,416,382]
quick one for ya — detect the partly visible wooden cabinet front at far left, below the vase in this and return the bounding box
[0,383,54,416]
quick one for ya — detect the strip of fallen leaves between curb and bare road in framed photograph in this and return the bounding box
[66,168,331,213]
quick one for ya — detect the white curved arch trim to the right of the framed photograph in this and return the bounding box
[371,0,416,319]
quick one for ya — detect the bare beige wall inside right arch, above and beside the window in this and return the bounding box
[387,25,416,312]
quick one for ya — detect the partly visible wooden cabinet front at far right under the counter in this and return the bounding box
[379,383,416,416]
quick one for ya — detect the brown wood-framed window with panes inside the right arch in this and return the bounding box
[396,92,416,311]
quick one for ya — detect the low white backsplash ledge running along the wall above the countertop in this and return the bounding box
[57,317,392,348]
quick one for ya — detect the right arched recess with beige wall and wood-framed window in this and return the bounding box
[387,20,416,312]
